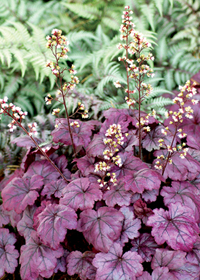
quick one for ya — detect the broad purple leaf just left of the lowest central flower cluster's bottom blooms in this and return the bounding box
[60,178,102,211]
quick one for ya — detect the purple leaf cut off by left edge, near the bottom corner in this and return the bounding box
[0,228,19,277]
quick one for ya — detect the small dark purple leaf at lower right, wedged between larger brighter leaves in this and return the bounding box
[131,232,158,262]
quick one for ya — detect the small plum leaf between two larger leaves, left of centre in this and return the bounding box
[41,179,67,199]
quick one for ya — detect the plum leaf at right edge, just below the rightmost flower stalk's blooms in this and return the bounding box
[153,150,200,181]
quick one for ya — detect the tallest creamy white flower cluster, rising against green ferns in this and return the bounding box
[114,6,154,107]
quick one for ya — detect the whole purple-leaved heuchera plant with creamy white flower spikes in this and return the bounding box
[0,6,200,280]
